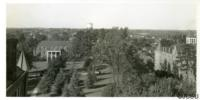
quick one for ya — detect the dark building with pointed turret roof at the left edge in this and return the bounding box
[6,39,28,96]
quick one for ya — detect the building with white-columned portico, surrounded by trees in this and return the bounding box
[35,41,71,61]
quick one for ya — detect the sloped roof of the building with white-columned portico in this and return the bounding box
[38,41,68,47]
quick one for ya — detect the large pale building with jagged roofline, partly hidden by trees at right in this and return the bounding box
[154,41,196,82]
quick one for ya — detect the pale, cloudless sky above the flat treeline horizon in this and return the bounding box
[6,0,196,30]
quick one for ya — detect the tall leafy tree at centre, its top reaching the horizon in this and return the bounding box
[93,29,129,87]
